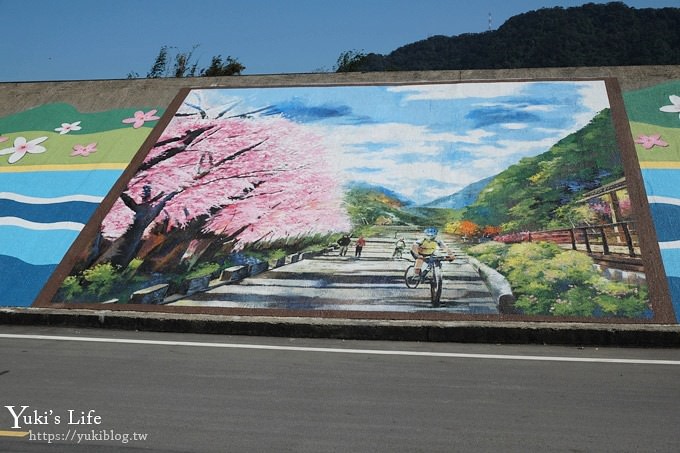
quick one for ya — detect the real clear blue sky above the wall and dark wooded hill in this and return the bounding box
[0,0,679,82]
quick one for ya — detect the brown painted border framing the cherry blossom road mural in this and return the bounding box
[32,77,676,324]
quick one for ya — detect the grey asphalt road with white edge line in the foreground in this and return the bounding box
[0,326,680,452]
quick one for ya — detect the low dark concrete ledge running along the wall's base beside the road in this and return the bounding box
[0,308,680,348]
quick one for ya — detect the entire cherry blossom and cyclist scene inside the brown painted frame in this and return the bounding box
[51,80,654,320]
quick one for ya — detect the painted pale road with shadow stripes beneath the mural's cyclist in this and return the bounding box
[171,234,498,314]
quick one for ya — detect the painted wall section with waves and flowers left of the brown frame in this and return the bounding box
[0,104,159,307]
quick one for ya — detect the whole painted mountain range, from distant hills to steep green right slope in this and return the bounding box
[345,109,624,231]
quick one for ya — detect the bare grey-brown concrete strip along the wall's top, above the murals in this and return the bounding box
[0,66,680,117]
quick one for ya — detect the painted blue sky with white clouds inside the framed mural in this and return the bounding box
[180,81,609,203]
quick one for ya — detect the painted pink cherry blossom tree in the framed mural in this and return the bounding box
[97,117,349,266]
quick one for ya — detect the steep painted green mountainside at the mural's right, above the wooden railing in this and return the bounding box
[463,109,623,232]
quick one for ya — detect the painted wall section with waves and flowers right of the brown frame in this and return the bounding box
[624,80,680,319]
